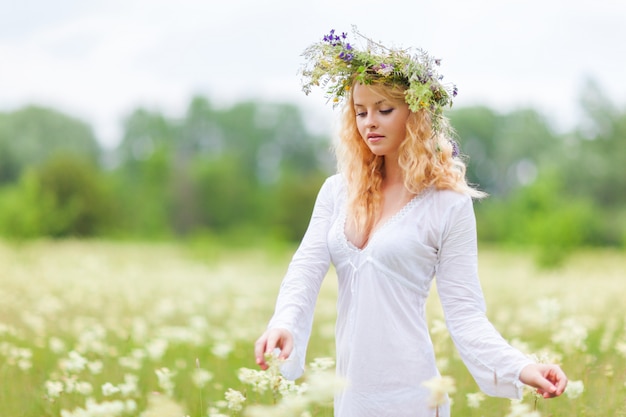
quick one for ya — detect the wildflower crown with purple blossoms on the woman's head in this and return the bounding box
[301,27,457,128]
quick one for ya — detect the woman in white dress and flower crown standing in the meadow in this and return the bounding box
[255,27,567,417]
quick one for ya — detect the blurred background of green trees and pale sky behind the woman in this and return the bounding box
[0,0,626,265]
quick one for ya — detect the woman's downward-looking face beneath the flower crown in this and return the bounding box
[352,83,411,158]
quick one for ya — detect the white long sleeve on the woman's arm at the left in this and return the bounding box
[268,176,337,379]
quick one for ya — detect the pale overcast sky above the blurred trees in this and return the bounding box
[0,0,626,146]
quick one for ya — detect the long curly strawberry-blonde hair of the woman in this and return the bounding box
[335,83,486,236]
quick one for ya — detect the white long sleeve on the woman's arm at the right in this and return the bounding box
[436,193,532,398]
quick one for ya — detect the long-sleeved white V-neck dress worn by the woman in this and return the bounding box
[268,175,531,417]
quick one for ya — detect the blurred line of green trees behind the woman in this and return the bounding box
[0,81,626,262]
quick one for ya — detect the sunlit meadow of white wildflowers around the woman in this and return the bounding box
[0,241,626,417]
